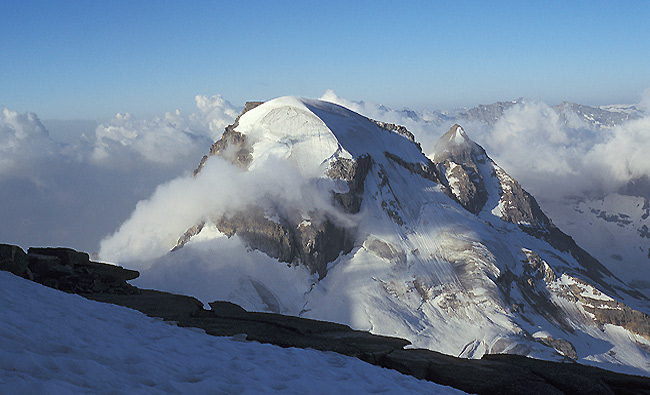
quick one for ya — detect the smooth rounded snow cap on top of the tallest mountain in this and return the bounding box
[235,97,421,170]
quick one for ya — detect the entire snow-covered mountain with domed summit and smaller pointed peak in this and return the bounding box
[106,98,650,374]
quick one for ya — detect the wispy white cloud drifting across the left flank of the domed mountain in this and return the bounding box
[99,156,346,267]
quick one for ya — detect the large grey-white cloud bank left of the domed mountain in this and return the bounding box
[0,95,240,252]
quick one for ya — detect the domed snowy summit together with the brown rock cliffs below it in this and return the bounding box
[175,97,436,278]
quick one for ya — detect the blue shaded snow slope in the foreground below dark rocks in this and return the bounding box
[0,272,462,394]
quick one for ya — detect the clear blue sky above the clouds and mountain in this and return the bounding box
[0,0,650,119]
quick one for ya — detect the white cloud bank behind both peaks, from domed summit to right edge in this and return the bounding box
[321,90,650,202]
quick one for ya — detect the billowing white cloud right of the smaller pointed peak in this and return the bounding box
[468,101,650,201]
